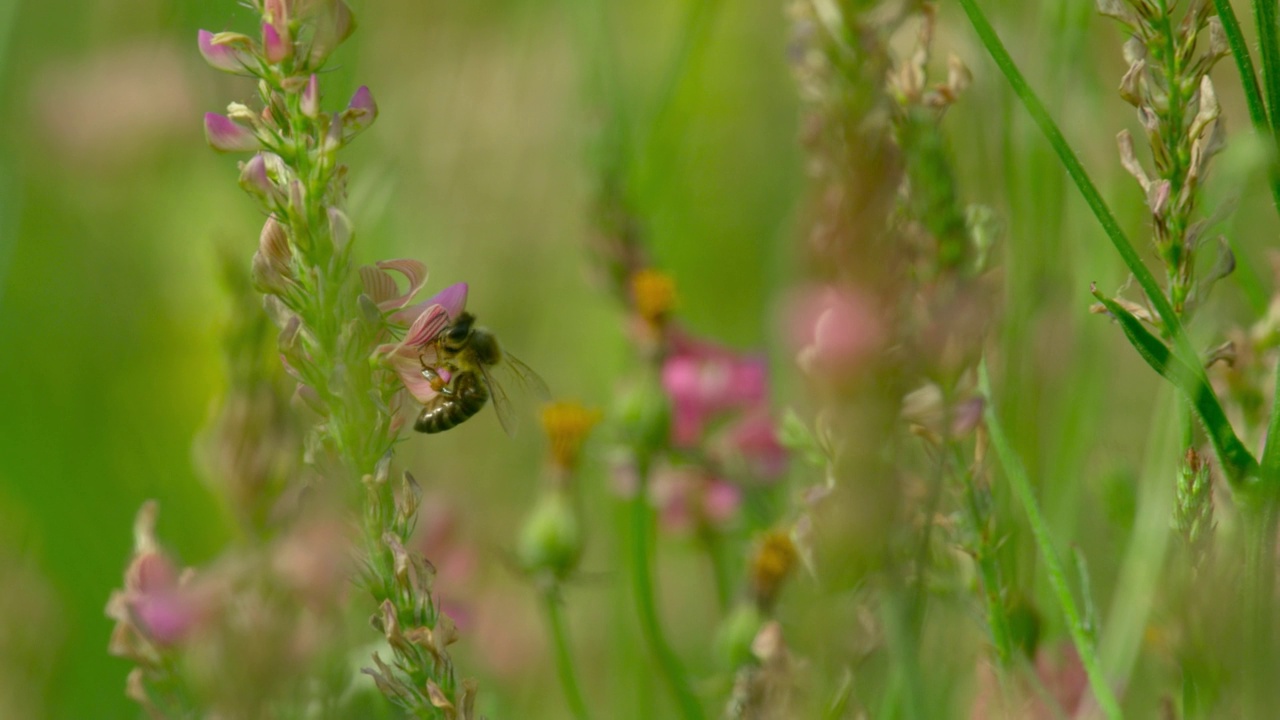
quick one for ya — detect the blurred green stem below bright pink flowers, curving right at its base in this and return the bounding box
[628,457,705,720]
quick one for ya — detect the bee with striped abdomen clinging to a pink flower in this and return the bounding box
[413,313,550,436]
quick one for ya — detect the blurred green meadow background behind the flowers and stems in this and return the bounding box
[0,0,1275,719]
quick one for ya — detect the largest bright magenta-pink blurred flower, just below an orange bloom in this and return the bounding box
[662,337,768,447]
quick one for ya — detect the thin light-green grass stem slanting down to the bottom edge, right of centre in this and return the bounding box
[977,363,1123,719]
